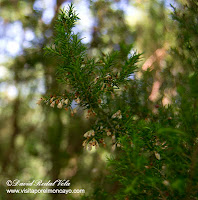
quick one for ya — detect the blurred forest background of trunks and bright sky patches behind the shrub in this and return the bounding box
[0,0,198,200]
